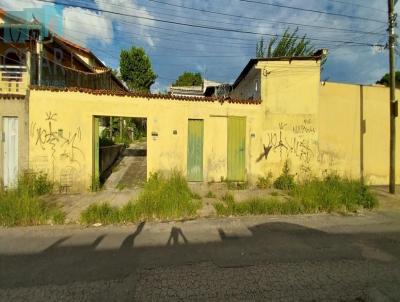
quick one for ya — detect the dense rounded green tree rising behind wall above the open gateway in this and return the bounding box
[119,47,157,92]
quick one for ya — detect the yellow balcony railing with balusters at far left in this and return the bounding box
[0,65,28,94]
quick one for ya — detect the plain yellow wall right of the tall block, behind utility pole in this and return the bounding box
[319,83,400,185]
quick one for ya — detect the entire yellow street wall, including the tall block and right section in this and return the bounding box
[29,61,400,191]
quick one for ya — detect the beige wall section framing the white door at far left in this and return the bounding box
[0,94,29,184]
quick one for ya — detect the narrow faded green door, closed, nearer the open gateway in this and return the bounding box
[187,120,204,181]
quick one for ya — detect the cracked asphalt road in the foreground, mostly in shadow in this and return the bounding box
[0,212,400,301]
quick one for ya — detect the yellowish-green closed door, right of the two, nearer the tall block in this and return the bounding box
[228,117,246,181]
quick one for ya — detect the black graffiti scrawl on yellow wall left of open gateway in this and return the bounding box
[30,111,85,187]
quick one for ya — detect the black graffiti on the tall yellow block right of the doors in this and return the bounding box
[257,119,317,163]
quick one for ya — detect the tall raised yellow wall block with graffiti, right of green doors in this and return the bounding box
[256,60,320,177]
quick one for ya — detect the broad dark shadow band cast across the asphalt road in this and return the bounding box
[0,222,400,300]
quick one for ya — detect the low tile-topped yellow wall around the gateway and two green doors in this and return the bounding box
[29,90,262,191]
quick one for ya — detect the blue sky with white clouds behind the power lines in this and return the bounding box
[0,0,398,91]
